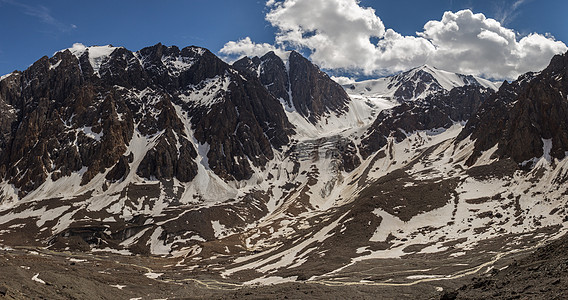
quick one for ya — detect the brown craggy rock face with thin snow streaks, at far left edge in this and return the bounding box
[0,51,133,193]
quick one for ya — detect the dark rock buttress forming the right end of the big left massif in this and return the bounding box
[139,45,293,180]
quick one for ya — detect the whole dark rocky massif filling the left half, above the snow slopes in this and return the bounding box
[0,44,293,196]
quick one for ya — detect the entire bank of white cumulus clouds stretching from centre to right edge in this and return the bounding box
[220,0,568,79]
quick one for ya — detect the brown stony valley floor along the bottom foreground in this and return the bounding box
[0,233,556,299]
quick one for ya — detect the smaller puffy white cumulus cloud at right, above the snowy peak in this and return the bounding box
[418,10,567,78]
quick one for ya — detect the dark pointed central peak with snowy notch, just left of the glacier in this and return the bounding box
[233,51,349,123]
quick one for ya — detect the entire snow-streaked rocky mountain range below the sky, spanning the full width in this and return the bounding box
[0,44,568,297]
